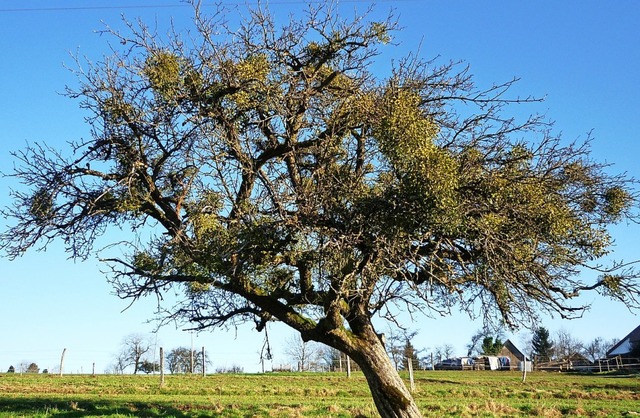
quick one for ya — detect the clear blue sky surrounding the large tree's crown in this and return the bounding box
[0,0,640,373]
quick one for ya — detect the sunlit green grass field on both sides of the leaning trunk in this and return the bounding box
[0,371,640,418]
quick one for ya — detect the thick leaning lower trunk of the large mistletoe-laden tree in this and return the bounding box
[352,334,422,418]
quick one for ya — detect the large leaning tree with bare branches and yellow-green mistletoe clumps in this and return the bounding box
[0,1,639,417]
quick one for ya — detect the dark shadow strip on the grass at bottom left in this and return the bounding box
[0,398,253,418]
